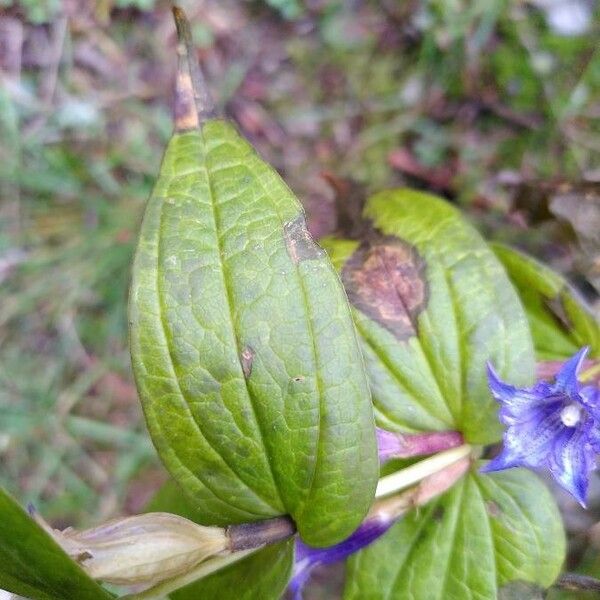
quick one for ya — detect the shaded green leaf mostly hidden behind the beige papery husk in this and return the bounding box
[146,481,294,600]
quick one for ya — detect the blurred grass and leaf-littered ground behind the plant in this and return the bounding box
[0,0,600,592]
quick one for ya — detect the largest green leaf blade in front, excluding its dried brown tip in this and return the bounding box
[130,120,378,545]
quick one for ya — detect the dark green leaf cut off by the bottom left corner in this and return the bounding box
[0,488,112,600]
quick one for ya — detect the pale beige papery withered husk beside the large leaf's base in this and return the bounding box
[36,513,231,586]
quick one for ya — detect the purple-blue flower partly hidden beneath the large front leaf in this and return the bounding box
[288,514,396,600]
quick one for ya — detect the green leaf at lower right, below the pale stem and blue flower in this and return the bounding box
[344,469,565,600]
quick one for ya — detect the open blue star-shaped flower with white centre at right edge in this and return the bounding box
[482,348,600,507]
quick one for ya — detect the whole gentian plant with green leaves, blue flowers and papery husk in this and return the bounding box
[0,4,600,600]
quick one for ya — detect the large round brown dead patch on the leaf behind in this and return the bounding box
[342,236,429,340]
